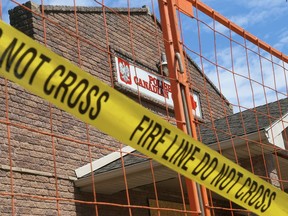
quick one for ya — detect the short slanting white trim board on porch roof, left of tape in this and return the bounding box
[75,146,135,178]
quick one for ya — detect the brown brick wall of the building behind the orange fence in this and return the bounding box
[0,2,286,216]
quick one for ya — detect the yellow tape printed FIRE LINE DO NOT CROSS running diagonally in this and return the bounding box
[0,21,288,216]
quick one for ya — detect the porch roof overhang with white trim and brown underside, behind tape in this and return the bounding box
[75,113,288,194]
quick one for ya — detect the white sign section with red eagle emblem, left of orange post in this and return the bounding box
[115,57,173,106]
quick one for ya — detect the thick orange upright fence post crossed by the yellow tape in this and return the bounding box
[159,0,210,215]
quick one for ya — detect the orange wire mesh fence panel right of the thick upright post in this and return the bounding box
[179,1,287,215]
